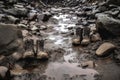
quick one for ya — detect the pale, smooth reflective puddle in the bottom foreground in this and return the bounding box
[44,62,98,80]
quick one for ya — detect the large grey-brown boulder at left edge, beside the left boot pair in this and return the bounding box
[0,24,23,55]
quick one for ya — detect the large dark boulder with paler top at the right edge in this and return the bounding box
[96,14,120,38]
